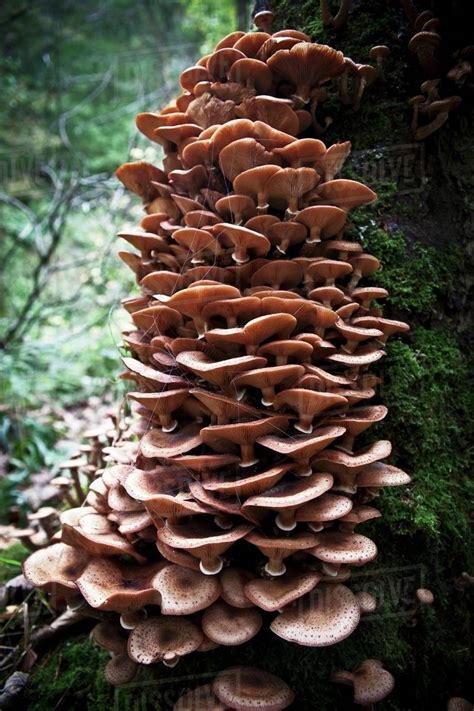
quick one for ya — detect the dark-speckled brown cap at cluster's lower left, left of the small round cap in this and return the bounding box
[128,616,203,664]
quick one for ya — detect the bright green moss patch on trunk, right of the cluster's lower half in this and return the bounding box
[381,327,474,550]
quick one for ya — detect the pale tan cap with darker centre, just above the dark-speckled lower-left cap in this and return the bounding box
[153,565,221,615]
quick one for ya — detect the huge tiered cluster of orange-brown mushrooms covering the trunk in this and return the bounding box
[25,20,409,683]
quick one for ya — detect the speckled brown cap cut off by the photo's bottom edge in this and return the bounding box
[212,667,294,711]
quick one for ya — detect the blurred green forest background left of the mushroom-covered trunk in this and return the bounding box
[0,0,250,523]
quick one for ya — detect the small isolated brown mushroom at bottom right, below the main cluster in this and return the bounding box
[331,659,395,706]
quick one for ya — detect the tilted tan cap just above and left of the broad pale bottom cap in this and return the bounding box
[245,573,321,612]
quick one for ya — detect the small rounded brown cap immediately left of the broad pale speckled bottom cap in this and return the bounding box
[201,601,262,647]
